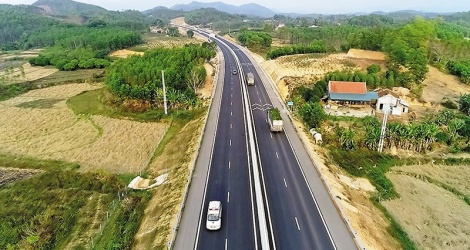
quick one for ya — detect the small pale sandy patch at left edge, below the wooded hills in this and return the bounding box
[0,63,59,84]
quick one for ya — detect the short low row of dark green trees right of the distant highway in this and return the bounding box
[266,40,331,59]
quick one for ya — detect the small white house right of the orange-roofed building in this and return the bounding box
[376,89,410,115]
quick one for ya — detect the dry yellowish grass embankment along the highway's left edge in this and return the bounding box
[133,112,205,249]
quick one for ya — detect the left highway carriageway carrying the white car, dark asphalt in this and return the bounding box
[196,37,257,249]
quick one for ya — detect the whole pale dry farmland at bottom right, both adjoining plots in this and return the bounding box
[382,165,470,249]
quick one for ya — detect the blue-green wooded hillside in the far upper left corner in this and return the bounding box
[0,5,150,50]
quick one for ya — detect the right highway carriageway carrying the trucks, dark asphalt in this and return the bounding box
[225,40,335,249]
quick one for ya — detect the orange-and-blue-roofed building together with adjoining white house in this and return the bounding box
[328,81,409,115]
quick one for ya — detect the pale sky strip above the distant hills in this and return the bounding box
[0,0,470,14]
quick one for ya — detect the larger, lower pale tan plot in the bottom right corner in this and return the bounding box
[382,174,470,250]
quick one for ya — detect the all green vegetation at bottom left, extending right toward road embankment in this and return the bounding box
[0,164,149,249]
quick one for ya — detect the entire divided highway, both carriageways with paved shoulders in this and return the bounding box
[175,27,357,250]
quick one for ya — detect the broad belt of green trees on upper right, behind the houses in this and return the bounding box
[274,16,470,85]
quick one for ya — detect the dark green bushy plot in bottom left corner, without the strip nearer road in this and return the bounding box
[0,170,123,249]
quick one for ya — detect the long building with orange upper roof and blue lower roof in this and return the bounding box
[328,81,378,105]
